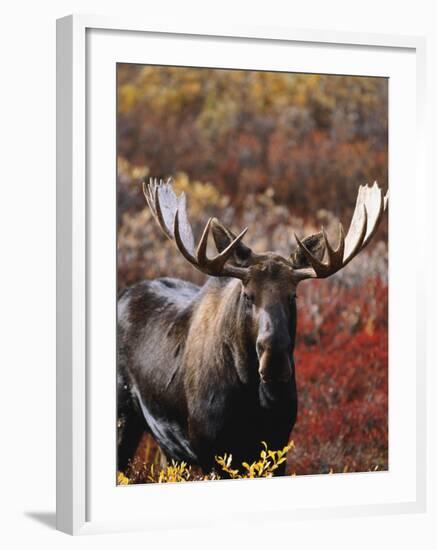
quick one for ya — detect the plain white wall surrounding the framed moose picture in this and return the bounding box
[0,0,437,550]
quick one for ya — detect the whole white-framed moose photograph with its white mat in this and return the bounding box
[57,16,426,534]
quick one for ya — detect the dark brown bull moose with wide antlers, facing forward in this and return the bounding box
[117,180,387,474]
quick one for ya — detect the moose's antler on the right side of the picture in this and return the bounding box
[295,182,388,280]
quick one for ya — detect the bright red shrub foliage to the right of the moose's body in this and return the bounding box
[288,279,388,474]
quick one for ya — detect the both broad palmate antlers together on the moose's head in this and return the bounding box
[143,178,388,282]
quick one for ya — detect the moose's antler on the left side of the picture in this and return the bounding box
[143,178,247,279]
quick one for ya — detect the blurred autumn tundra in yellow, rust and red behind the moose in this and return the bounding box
[117,64,388,475]
